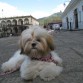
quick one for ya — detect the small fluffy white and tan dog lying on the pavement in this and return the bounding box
[1,26,62,81]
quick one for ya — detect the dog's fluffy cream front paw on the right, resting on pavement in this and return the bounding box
[39,66,62,81]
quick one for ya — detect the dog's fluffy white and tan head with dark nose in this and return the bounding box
[20,27,54,58]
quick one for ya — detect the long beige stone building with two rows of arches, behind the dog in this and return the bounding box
[0,15,39,35]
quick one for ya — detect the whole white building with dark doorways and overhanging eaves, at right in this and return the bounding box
[62,0,83,30]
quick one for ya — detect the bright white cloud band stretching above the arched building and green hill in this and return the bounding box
[0,2,68,18]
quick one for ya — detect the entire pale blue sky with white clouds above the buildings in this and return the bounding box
[0,0,70,19]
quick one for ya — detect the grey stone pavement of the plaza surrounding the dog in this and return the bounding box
[0,31,83,83]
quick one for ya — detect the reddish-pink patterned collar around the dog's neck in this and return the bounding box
[31,54,58,64]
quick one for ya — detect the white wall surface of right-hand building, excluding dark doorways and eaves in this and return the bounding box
[62,0,83,29]
